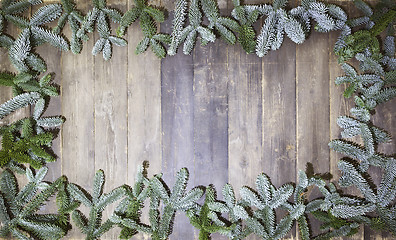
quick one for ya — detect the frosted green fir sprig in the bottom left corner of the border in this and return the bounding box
[0,168,67,239]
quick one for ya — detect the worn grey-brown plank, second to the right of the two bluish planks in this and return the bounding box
[258,38,296,239]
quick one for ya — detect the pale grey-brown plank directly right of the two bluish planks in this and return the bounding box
[228,45,263,193]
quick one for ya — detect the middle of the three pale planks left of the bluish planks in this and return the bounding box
[93,0,128,239]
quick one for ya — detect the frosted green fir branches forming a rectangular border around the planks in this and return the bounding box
[0,0,396,240]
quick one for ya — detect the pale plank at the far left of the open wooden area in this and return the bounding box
[61,2,95,239]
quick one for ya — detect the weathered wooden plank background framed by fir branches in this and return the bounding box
[1,0,396,239]
